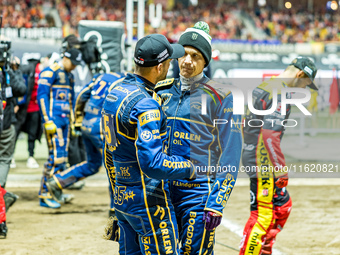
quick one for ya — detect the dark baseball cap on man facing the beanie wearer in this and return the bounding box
[134,34,185,67]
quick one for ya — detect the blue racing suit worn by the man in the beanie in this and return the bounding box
[155,76,242,255]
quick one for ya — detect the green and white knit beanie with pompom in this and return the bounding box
[178,21,212,67]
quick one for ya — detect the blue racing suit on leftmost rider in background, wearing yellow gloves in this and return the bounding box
[37,62,74,198]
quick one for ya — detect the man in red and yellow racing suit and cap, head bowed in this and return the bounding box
[240,57,318,255]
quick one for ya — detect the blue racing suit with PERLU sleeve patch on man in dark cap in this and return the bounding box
[102,74,195,255]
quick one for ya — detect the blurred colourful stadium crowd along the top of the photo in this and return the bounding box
[0,0,340,43]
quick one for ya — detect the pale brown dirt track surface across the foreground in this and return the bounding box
[0,182,340,255]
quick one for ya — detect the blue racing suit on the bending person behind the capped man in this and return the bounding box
[54,73,124,211]
